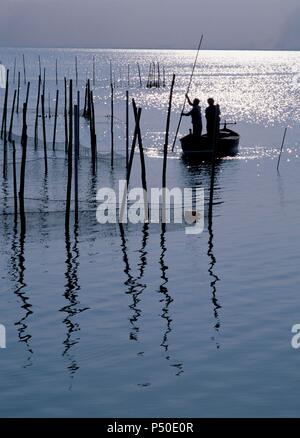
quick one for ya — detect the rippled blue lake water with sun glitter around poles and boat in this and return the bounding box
[0,48,300,417]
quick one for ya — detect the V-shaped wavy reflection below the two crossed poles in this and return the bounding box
[119,223,149,341]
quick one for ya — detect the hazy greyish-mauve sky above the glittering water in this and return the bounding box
[0,0,300,50]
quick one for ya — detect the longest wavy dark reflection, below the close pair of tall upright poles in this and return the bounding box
[60,224,88,384]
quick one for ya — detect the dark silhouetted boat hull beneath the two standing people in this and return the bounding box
[180,125,240,160]
